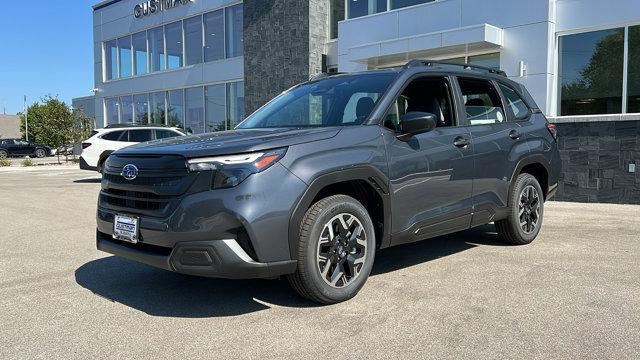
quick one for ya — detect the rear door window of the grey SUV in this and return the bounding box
[458,79,506,125]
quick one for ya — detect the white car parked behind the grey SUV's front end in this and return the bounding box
[80,124,186,173]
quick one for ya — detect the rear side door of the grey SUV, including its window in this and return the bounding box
[457,77,529,226]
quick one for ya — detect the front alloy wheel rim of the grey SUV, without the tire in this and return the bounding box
[316,213,367,288]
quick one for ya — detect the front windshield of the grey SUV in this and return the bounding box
[237,72,396,129]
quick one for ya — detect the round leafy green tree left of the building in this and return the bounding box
[20,96,74,162]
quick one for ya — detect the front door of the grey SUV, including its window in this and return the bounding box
[383,76,473,245]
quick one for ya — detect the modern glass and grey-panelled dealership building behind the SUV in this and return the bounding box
[78,0,640,203]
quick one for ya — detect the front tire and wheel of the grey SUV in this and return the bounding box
[287,195,376,304]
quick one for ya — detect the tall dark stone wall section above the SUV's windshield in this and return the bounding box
[243,0,329,114]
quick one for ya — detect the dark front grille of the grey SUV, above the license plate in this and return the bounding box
[99,155,197,217]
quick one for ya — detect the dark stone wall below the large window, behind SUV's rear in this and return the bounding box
[555,121,640,204]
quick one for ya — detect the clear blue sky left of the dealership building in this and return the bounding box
[0,0,98,114]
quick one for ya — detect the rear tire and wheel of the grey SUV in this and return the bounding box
[495,173,544,245]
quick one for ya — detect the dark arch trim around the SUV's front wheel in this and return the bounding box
[288,166,391,260]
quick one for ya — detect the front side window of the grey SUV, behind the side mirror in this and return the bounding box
[384,77,455,131]
